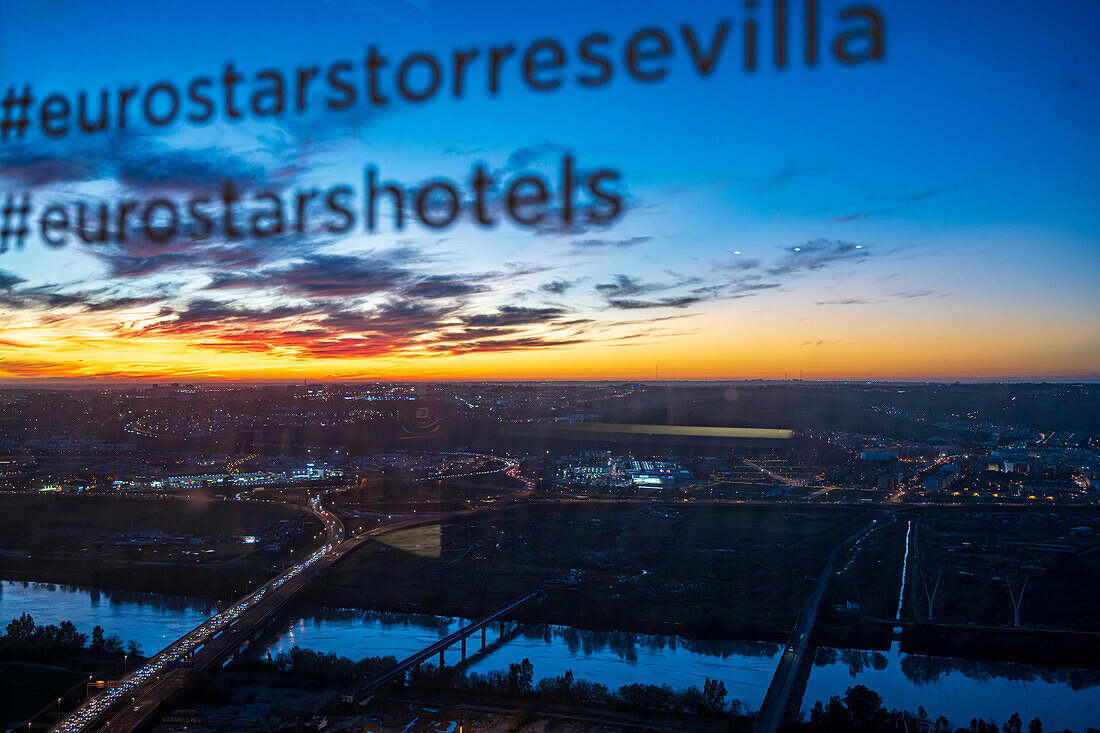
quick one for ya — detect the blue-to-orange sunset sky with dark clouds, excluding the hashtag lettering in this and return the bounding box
[0,0,1100,382]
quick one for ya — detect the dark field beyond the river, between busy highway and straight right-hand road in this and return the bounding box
[307,503,865,638]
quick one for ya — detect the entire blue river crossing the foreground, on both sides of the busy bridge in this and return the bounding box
[0,581,1100,731]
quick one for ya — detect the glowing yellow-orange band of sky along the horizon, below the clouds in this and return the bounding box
[0,305,1100,382]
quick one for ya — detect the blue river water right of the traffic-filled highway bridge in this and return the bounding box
[259,609,1100,731]
